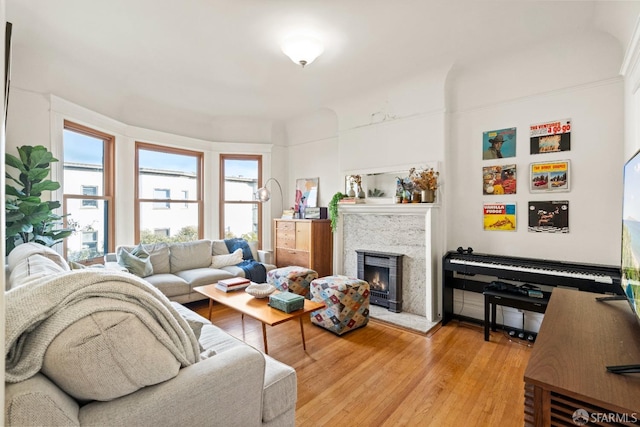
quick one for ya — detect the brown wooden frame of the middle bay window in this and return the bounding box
[133,141,204,244]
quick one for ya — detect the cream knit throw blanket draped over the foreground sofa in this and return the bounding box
[5,270,199,383]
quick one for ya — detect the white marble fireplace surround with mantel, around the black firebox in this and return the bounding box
[334,203,440,332]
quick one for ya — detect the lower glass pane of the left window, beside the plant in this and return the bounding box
[66,199,109,261]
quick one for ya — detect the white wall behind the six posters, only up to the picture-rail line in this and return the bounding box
[447,79,623,265]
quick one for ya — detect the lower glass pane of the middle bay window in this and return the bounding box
[140,202,199,243]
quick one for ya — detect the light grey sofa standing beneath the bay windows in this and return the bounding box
[105,239,275,303]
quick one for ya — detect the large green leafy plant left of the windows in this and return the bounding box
[5,145,75,253]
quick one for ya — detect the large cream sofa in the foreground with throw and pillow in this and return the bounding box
[4,244,297,426]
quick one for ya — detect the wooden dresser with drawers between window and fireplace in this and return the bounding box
[273,219,333,277]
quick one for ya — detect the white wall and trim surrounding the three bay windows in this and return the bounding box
[7,92,272,250]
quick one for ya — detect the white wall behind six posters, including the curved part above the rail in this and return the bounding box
[447,33,624,265]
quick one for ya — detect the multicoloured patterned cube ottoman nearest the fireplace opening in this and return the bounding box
[311,276,369,335]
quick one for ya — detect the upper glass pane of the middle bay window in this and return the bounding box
[138,149,198,200]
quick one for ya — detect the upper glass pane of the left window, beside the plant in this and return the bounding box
[63,129,104,196]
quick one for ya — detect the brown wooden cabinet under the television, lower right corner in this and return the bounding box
[524,288,640,426]
